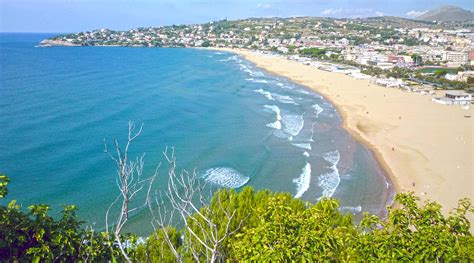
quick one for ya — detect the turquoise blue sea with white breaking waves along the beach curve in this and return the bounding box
[0,34,392,233]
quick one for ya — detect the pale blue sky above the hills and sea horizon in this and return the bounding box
[0,0,474,32]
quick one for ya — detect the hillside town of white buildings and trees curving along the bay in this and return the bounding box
[40,17,474,98]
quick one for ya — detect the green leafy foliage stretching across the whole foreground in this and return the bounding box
[0,177,474,262]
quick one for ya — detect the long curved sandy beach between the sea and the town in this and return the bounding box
[218,49,474,221]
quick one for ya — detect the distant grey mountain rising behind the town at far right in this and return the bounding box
[416,6,474,21]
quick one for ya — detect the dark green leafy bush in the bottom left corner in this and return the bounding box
[0,175,124,262]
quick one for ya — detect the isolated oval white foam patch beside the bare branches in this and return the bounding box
[202,167,250,188]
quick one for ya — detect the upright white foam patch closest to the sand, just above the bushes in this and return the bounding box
[319,150,341,198]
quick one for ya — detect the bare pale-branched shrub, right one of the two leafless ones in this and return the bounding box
[149,148,240,262]
